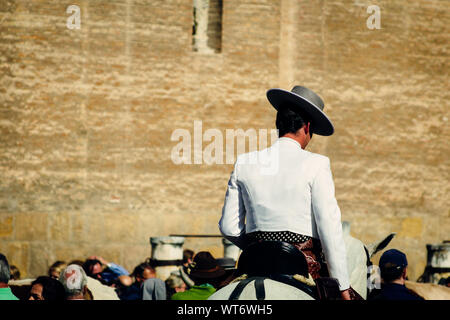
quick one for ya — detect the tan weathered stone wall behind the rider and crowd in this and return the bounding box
[0,0,450,279]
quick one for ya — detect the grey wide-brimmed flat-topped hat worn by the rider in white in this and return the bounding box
[267,86,334,136]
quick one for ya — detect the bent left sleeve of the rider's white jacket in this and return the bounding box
[219,163,245,247]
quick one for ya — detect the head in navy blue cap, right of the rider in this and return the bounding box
[379,249,408,283]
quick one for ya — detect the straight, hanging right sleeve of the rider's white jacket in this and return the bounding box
[311,158,350,291]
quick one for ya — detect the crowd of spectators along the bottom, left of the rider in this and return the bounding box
[0,249,234,300]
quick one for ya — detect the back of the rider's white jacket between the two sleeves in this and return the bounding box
[230,138,329,238]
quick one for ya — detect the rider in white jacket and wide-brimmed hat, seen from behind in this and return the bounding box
[219,86,353,300]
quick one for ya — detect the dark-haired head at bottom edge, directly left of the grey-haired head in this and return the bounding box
[29,276,66,301]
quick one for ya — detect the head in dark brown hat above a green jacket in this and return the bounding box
[189,251,225,287]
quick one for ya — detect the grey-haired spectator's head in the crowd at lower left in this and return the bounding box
[59,264,87,300]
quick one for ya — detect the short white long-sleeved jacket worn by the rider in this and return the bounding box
[219,137,350,290]
